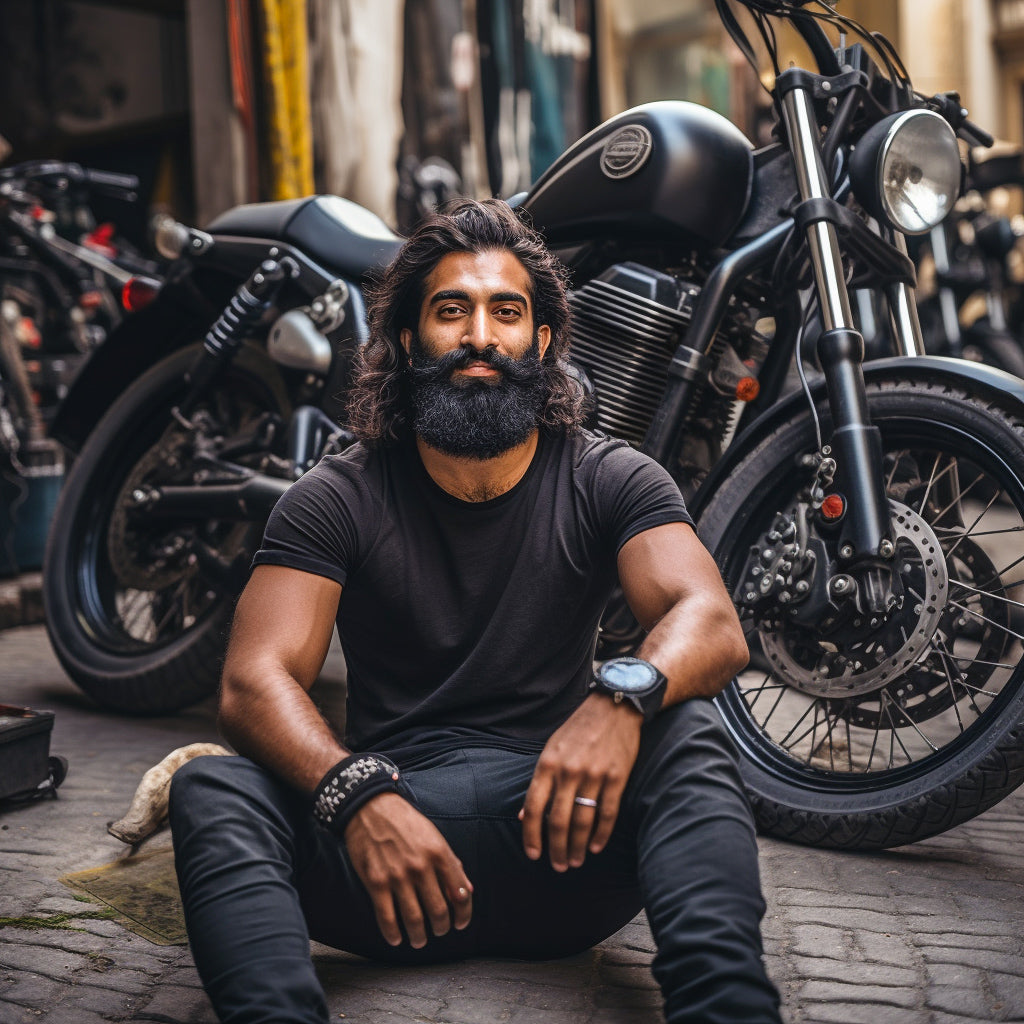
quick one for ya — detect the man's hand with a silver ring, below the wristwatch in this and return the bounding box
[519,694,643,871]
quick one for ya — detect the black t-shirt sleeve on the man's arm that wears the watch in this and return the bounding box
[594,442,693,553]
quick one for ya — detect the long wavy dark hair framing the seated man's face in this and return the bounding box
[347,199,584,444]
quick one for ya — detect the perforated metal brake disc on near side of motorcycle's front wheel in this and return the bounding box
[759,501,949,698]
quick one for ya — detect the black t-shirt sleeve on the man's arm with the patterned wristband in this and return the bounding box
[253,463,365,586]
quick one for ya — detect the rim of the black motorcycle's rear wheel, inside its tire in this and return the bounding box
[68,368,282,657]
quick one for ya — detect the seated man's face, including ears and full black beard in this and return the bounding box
[401,250,551,459]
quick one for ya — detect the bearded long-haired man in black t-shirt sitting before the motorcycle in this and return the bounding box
[171,195,778,1024]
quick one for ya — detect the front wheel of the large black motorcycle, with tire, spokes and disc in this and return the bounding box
[698,377,1024,850]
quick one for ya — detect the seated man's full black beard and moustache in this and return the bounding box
[409,334,546,460]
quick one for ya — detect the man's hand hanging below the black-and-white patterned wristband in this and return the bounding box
[345,793,473,949]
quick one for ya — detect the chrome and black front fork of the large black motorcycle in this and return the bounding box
[778,83,901,610]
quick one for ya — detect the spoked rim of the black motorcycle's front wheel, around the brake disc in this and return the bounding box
[719,417,1024,794]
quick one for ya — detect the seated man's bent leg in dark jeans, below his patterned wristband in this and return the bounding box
[170,757,346,1024]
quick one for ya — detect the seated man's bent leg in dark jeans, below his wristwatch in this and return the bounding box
[624,700,778,1024]
